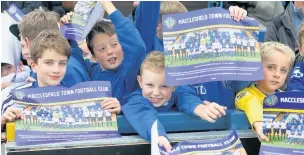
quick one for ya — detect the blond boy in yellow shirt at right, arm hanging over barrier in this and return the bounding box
[235,42,295,141]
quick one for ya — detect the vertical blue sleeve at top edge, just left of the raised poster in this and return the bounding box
[135,1,160,53]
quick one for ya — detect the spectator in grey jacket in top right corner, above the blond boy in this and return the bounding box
[265,1,304,63]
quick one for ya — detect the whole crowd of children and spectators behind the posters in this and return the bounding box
[1,1,304,151]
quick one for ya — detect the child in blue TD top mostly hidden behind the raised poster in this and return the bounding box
[135,1,251,109]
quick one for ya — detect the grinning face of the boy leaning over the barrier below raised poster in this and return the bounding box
[137,69,175,107]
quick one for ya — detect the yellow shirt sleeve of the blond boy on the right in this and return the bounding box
[235,91,263,125]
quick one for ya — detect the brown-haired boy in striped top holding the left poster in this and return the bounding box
[1,30,71,130]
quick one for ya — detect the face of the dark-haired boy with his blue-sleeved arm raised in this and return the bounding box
[93,33,123,69]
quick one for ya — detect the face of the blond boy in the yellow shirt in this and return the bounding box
[258,52,291,94]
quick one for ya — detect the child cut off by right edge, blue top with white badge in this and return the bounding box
[288,22,304,91]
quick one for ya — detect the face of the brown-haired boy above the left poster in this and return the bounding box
[32,49,68,87]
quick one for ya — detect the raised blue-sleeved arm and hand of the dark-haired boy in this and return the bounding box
[102,1,146,91]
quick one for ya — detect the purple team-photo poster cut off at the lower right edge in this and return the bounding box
[260,92,304,155]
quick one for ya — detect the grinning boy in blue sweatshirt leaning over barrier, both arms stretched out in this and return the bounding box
[122,52,226,152]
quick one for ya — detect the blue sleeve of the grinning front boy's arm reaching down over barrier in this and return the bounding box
[122,93,167,141]
